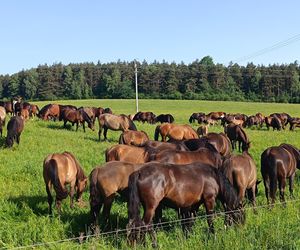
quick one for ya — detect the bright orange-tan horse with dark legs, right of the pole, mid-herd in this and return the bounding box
[154,123,199,142]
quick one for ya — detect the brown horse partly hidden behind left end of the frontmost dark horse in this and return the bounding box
[89,161,143,227]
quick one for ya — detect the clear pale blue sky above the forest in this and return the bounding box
[0,0,300,74]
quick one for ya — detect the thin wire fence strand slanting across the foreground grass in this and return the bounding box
[0,199,300,249]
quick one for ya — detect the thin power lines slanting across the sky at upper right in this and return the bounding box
[233,34,300,62]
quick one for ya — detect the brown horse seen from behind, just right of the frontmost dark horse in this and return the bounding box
[221,151,257,207]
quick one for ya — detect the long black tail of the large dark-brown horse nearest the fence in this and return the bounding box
[127,171,144,239]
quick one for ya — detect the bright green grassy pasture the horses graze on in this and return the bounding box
[0,100,300,249]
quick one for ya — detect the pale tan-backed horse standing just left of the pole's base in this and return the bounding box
[98,113,137,141]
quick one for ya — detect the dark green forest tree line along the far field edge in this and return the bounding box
[0,56,300,103]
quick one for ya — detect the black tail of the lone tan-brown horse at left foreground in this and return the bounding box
[46,159,68,200]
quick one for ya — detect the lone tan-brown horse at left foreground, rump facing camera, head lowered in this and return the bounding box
[43,152,87,215]
